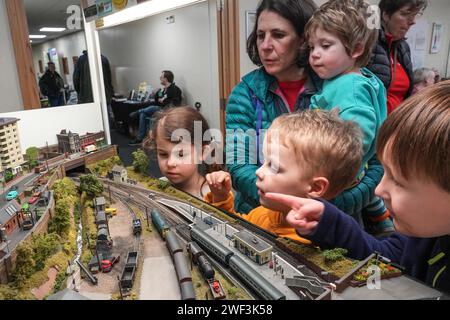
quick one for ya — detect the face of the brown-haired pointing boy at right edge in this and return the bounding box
[375,152,450,238]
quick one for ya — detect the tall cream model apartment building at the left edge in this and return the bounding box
[0,118,24,174]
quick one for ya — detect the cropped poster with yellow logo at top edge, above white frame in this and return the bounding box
[81,0,149,22]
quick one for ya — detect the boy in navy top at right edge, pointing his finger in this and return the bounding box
[266,81,450,293]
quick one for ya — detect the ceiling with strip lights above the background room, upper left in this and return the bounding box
[23,0,84,45]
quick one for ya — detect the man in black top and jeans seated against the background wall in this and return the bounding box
[129,70,181,146]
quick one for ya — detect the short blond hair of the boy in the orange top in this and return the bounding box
[268,109,363,199]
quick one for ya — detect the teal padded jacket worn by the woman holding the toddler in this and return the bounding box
[226,68,384,218]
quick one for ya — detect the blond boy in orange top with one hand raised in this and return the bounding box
[205,109,362,244]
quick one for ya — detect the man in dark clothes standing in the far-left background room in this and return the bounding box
[39,62,65,107]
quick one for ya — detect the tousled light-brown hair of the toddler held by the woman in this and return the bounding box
[305,0,378,68]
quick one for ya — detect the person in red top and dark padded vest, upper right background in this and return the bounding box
[368,0,428,115]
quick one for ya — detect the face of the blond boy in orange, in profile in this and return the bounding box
[256,134,311,213]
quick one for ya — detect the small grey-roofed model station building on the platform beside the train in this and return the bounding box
[232,230,273,265]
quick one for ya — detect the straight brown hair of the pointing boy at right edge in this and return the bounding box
[377,81,450,192]
